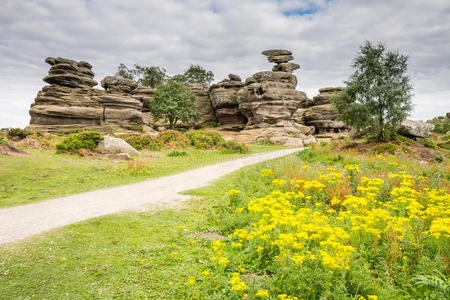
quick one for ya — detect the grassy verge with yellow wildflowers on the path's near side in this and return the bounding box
[0,145,450,300]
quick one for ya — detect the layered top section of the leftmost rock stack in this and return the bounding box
[43,57,97,88]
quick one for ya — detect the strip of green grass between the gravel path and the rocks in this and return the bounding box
[0,145,282,208]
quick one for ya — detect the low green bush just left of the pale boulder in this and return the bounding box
[56,131,103,153]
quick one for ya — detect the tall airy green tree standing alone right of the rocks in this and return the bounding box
[332,41,412,141]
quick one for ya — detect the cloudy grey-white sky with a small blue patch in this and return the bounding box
[0,0,450,128]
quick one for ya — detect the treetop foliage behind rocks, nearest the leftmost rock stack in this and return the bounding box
[115,63,167,88]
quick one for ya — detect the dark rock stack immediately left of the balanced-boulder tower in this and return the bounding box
[209,74,247,130]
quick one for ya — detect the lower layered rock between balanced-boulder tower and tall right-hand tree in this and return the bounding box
[296,87,347,134]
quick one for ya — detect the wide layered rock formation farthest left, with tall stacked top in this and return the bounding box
[28,57,144,131]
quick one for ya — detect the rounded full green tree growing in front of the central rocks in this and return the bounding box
[149,80,201,129]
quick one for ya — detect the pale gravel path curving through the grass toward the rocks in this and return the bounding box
[0,148,301,244]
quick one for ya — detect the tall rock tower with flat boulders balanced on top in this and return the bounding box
[232,50,313,146]
